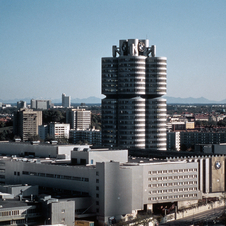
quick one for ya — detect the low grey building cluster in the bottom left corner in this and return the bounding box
[0,184,75,226]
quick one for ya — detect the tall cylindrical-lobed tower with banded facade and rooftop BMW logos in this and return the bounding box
[102,39,167,150]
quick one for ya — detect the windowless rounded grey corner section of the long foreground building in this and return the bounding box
[96,162,132,222]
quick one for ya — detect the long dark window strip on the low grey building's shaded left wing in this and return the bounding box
[22,171,89,182]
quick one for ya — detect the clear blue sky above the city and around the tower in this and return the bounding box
[0,0,226,100]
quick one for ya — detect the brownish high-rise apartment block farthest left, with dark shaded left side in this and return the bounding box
[13,108,42,141]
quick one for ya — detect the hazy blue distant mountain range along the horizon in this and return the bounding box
[0,96,226,104]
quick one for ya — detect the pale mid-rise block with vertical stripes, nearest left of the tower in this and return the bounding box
[66,109,91,130]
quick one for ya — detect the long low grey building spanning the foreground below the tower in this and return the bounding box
[0,143,225,225]
